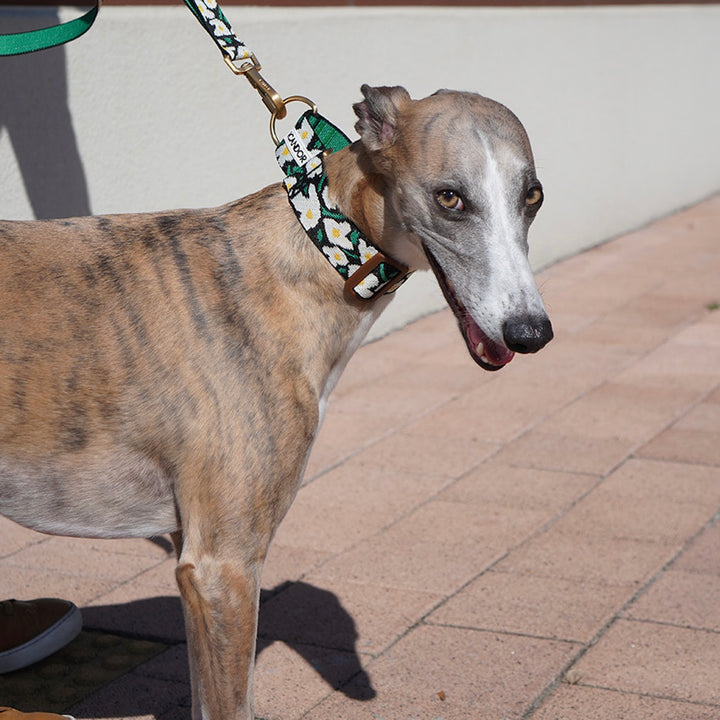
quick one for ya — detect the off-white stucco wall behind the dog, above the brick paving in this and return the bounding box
[0,0,720,335]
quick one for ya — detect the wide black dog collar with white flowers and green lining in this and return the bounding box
[275,110,411,300]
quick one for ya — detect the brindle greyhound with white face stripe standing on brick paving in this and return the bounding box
[0,86,552,720]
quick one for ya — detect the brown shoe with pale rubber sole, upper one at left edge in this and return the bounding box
[0,598,82,676]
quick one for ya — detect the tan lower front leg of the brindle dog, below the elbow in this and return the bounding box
[176,545,262,720]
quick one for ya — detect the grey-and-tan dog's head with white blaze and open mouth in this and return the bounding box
[354,85,553,370]
